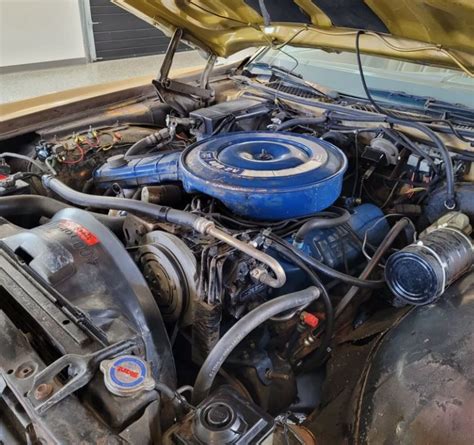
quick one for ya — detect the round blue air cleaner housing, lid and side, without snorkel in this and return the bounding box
[179,131,347,220]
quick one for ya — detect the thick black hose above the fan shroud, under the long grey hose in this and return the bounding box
[0,195,125,234]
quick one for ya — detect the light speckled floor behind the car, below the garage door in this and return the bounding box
[0,51,205,103]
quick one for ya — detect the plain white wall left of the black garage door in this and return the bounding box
[0,0,86,71]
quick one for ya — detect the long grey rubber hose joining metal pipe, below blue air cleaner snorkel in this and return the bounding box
[42,175,199,227]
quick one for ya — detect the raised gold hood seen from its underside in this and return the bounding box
[112,0,474,73]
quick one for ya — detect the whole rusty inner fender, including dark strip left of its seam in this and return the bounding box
[306,273,474,445]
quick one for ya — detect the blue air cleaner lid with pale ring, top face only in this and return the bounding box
[181,131,347,189]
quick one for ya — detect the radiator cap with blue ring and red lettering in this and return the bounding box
[100,355,155,397]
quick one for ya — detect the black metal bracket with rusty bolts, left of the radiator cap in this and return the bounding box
[28,340,137,415]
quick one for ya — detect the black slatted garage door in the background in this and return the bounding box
[89,0,185,60]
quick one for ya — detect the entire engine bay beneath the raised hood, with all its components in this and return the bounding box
[0,56,474,445]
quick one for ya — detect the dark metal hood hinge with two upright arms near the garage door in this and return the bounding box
[153,28,216,101]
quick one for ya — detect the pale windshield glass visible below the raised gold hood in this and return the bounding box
[249,46,474,108]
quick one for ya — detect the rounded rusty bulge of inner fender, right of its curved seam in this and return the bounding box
[353,273,474,445]
